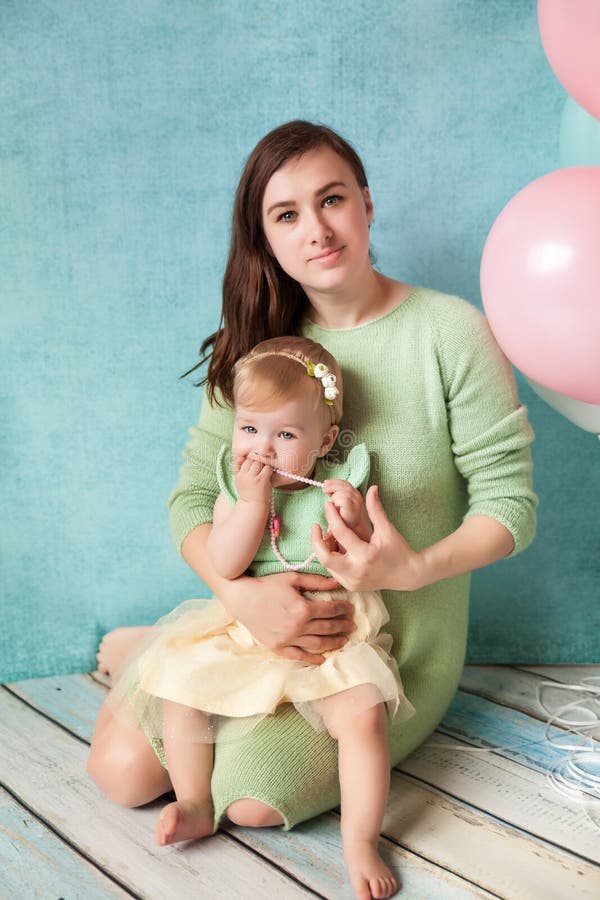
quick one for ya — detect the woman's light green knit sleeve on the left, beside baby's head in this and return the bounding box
[168,395,233,553]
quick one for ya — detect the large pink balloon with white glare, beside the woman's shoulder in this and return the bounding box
[481,166,600,403]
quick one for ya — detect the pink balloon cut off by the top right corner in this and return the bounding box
[538,0,600,118]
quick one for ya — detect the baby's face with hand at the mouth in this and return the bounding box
[232,396,337,487]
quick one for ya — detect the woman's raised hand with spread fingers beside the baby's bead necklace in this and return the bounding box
[311,485,428,591]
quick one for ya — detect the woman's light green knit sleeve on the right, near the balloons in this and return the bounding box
[436,298,537,556]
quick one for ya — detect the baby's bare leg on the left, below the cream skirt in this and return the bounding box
[156,700,214,845]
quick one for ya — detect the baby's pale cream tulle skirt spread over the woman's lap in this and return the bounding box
[109,590,414,742]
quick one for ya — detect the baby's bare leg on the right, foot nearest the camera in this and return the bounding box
[319,685,397,900]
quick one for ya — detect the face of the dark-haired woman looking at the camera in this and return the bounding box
[262,145,373,298]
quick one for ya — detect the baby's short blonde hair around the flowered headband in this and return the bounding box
[233,337,343,425]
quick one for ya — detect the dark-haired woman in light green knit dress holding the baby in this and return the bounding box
[90,114,536,880]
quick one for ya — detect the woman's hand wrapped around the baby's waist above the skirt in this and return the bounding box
[219,572,355,665]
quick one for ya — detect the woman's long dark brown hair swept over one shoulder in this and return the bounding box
[183,120,367,404]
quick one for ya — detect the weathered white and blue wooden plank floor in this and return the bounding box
[0,666,600,900]
